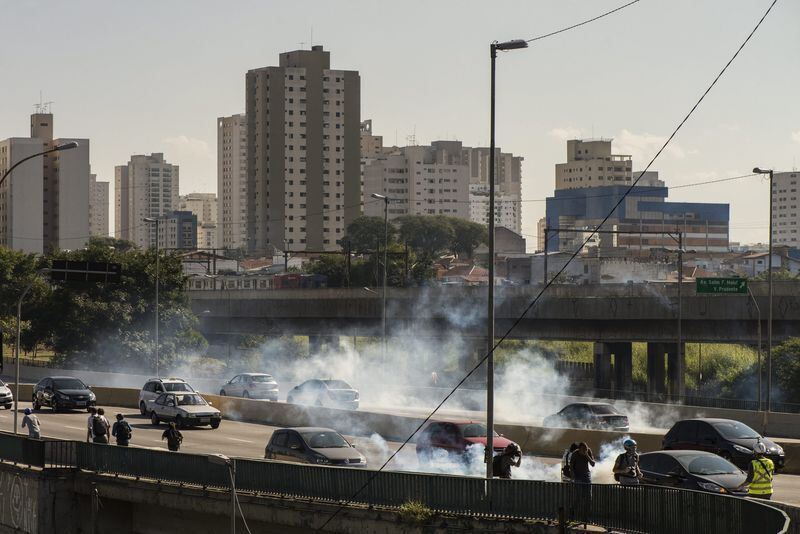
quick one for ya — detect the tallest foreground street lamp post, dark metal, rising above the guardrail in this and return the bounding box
[485,39,524,486]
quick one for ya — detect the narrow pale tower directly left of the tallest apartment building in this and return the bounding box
[217,113,247,249]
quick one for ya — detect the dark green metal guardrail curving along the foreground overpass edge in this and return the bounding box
[0,432,789,534]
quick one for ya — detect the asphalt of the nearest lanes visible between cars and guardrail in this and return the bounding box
[0,402,800,506]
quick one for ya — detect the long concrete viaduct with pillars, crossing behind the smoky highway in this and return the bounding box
[188,282,800,395]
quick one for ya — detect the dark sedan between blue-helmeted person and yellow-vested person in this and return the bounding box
[639,451,747,497]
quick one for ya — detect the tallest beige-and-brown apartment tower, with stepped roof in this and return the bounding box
[245,46,361,251]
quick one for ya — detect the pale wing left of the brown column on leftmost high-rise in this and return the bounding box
[0,137,44,254]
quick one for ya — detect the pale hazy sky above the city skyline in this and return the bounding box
[0,0,800,247]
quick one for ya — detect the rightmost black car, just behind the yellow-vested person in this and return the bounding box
[661,418,786,469]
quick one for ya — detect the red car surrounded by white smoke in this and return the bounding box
[417,421,514,461]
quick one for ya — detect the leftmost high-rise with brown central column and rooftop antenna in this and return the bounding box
[3,109,90,253]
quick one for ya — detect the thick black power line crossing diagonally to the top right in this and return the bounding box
[317,0,778,530]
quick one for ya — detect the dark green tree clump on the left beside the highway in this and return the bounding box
[0,243,207,369]
